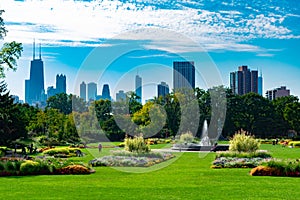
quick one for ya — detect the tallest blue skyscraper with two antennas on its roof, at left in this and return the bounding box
[25,42,45,104]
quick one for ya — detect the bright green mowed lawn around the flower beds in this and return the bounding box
[0,145,300,199]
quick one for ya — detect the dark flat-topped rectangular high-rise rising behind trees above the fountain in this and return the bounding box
[173,61,195,90]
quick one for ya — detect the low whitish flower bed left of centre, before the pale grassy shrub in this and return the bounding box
[89,151,175,167]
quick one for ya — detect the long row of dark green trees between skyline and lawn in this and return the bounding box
[0,82,300,145]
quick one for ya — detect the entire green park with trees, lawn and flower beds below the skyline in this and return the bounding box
[0,1,300,199]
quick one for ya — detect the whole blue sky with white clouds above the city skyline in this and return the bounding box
[0,0,300,99]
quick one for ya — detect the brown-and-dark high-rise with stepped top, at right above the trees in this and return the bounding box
[230,66,258,95]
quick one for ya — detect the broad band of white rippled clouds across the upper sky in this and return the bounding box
[0,0,299,51]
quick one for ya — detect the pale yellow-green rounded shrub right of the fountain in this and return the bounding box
[229,130,260,153]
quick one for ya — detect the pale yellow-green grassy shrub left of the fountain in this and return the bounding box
[124,135,150,152]
